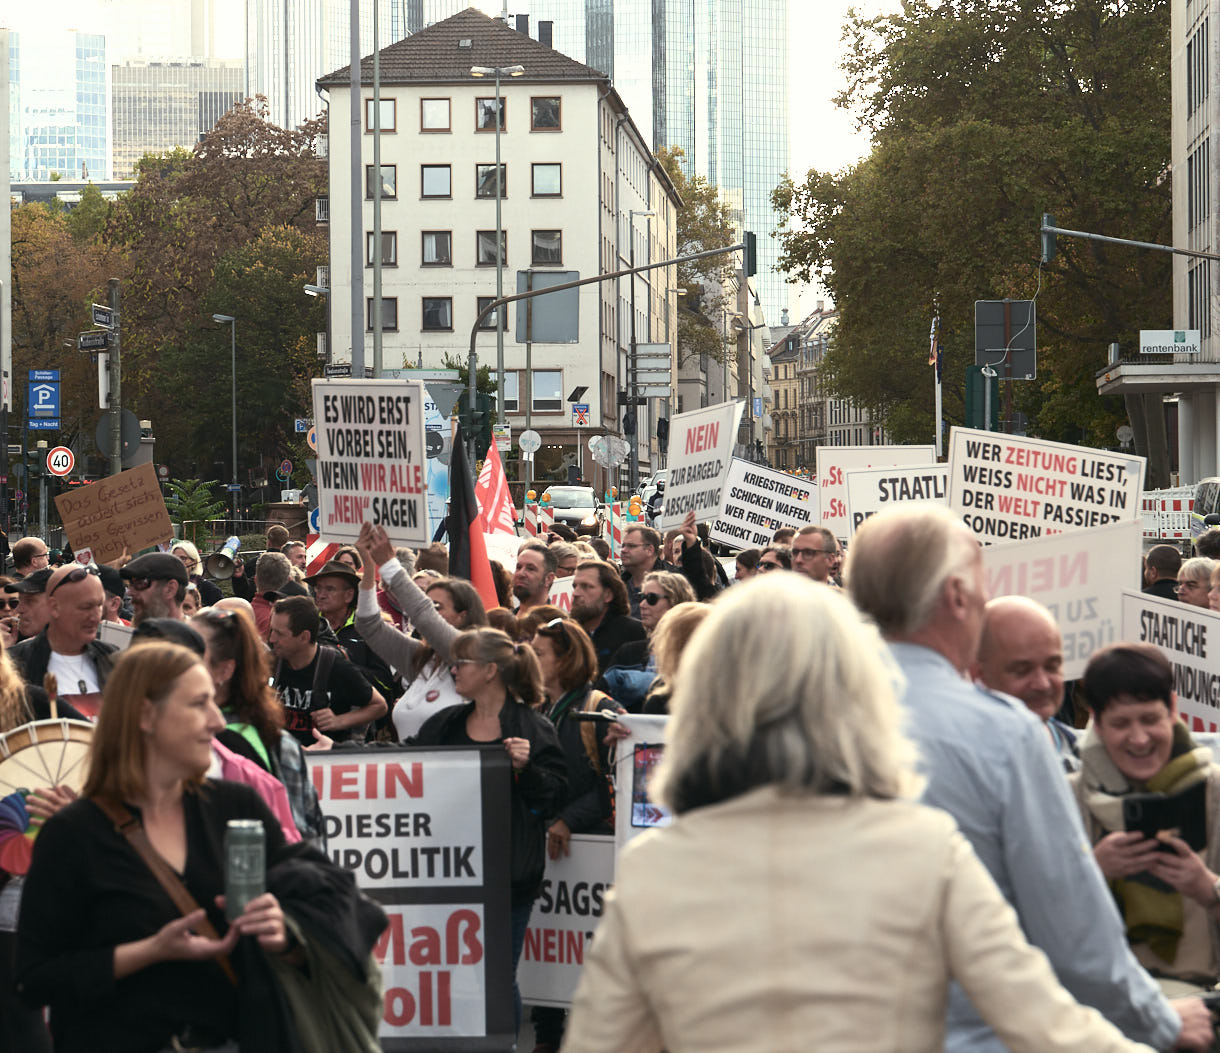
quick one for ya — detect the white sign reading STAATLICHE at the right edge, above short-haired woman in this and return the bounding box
[1122,589,1220,731]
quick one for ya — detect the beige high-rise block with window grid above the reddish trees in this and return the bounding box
[111,59,245,179]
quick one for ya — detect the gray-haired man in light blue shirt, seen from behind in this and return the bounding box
[845,505,1213,1053]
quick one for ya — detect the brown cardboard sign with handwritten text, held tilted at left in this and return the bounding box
[55,464,173,562]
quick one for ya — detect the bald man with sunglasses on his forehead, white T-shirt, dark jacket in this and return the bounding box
[10,556,117,720]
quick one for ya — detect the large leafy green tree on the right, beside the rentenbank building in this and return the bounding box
[773,0,1171,461]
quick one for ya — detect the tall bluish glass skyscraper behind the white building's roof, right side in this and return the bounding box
[406,0,794,318]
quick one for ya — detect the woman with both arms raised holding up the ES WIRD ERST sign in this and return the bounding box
[356,523,487,741]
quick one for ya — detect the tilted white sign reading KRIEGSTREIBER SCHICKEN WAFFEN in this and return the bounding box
[708,458,817,549]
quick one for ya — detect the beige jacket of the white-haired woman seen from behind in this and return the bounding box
[564,788,1148,1053]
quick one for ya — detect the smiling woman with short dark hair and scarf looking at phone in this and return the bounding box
[1069,643,1220,997]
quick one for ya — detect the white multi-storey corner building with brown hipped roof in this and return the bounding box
[318,10,680,487]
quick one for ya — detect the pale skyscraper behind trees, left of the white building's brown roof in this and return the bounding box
[245,0,405,128]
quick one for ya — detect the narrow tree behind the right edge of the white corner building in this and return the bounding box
[656,146,736,366]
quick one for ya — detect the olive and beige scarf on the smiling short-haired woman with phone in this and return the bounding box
[1080,721,1211,965]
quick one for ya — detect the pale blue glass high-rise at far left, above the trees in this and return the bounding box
[9,28,111,182]
